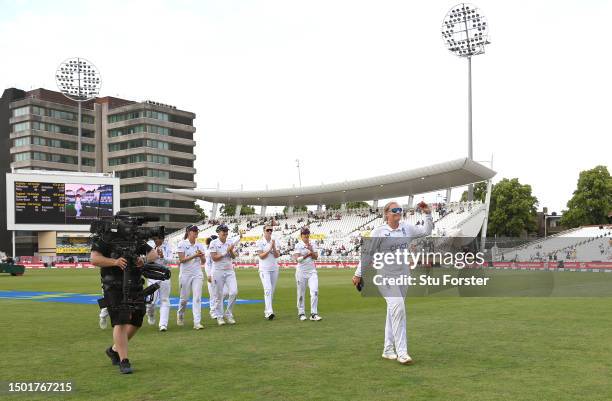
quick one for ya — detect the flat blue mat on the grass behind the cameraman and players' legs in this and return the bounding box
[0,290,263,308]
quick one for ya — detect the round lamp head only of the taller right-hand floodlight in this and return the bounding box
[442,3,489,57]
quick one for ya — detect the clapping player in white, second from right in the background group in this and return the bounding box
[255,225,280,320]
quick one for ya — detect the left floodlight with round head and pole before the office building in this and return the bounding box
[55,57,101,172]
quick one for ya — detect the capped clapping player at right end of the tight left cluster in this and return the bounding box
[209,224,240,326]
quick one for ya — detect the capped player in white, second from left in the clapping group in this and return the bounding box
[176,225,206,330]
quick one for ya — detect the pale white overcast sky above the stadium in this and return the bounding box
[0,0,612,216]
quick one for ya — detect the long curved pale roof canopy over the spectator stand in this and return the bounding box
[168,158,495,206]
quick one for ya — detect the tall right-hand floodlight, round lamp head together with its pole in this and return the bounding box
[441,3,490,201]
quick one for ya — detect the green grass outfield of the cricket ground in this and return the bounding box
[0,269,612,401]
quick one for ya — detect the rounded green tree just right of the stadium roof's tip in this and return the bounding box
[488,178,538,237]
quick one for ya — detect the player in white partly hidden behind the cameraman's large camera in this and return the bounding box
[147,233,172,331]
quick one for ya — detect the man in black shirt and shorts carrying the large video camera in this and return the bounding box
[91,237,157,374]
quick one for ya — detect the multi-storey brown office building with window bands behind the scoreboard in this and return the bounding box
[0,88,196,251]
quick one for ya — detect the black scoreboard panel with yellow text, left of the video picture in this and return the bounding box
[15,182,66,224]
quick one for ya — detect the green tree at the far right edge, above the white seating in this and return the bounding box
[560,166,612,228]
